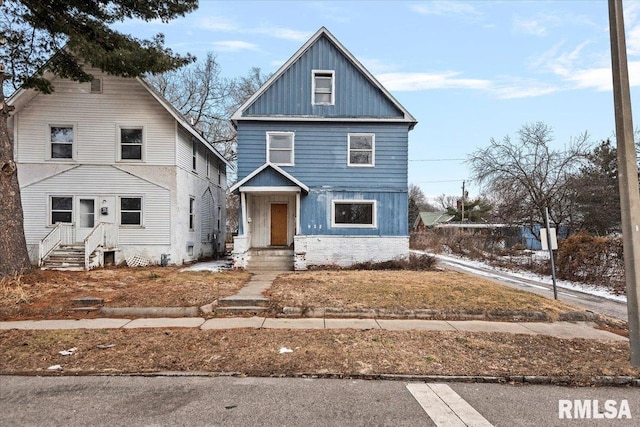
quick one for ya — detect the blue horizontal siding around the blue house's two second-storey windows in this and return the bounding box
[238,122,408,191]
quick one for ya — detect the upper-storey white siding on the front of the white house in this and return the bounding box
[14,69,176,165]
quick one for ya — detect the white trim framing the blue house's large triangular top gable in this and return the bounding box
[231,27,417,129]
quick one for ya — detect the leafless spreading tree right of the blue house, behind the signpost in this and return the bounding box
[467,122,589,232]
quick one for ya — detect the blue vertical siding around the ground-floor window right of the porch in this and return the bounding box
[300,190,408,236]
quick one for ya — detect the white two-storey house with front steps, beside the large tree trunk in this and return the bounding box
[7,68,228,268]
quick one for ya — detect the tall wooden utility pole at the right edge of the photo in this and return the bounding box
[609,0,640,366]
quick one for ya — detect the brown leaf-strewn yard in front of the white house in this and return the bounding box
[0,267,251,320]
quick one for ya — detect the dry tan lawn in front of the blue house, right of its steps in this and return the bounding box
[268,271,579,318]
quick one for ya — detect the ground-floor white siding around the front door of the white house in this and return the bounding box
[21,165,172,245]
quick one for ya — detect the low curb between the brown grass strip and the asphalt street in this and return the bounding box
[7,371,640,388]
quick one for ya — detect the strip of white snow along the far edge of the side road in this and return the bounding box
[412,250,627,303]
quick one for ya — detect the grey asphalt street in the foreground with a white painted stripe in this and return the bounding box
[0,375,640,427]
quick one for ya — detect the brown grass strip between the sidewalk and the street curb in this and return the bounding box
[0,329,640,383]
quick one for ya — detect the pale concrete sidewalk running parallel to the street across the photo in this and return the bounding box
[0,317,627,341]
